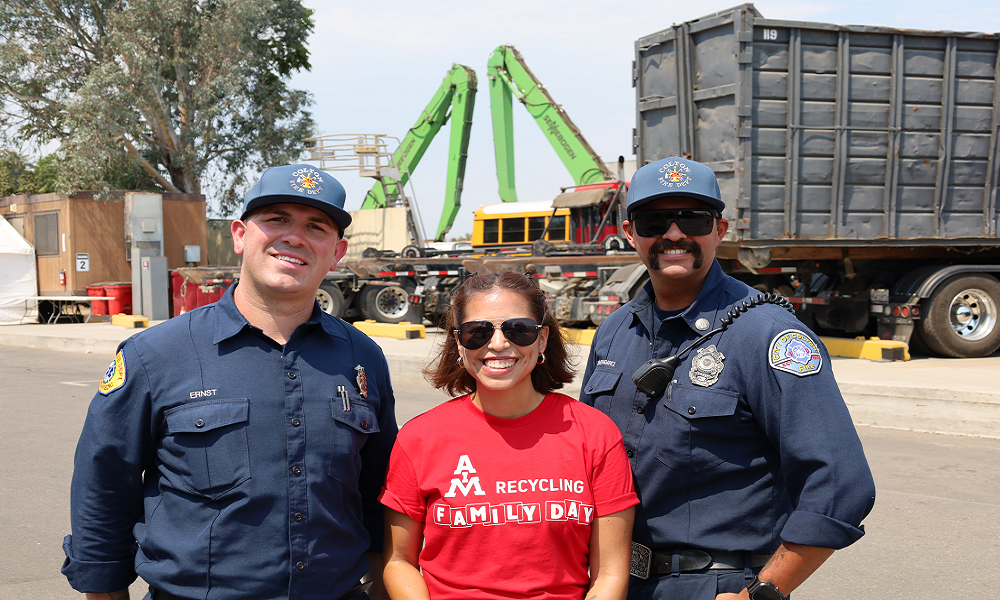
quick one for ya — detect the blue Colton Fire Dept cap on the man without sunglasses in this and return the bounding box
[240,165,351,235]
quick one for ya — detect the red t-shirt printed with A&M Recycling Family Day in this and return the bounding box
[379,394,639,600]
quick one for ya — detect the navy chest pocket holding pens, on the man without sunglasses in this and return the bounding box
[329,392,379,486]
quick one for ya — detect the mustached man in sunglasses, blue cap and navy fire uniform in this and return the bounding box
[580,157,875,600]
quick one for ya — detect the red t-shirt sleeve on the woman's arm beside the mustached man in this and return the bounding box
[587,409,639,517]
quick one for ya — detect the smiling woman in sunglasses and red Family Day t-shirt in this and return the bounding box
[380,271,639,600]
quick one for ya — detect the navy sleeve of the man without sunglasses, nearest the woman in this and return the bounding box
[358,355,399,552]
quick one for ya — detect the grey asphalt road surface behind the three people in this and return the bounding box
[0,346,1000,600]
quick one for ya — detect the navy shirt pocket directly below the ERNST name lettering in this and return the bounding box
[162,398,250,499]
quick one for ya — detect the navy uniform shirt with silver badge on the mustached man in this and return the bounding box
[580,262,875,553]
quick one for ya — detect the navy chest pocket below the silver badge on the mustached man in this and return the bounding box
[657,383,739,473]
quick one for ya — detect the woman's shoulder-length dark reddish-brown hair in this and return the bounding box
[424,271,573,396]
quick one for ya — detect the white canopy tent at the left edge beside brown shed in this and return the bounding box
[0,217,38,325]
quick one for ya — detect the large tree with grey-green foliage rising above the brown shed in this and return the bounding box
[0,0,313,210]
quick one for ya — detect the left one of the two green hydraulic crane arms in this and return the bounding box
[361,65,476,242]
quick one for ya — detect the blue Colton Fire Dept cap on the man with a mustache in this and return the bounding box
[626,156,726,215]
